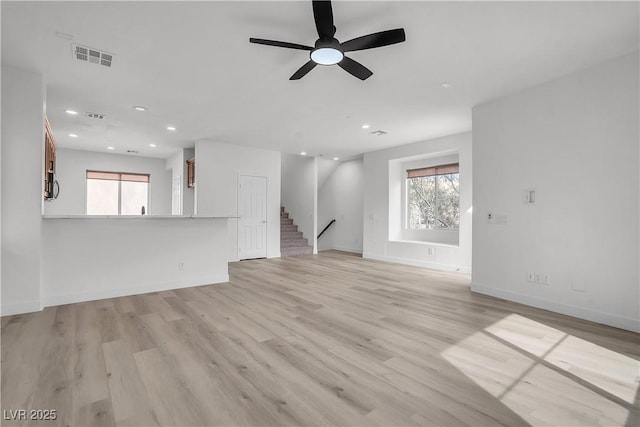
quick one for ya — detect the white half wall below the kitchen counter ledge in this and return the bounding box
[42,217,229,306]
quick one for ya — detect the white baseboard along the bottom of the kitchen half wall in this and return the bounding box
[42,274,229,307]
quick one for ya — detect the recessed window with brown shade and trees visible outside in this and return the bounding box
[407,163,460,229]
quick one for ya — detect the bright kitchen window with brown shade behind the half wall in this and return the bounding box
[87,171,149,215]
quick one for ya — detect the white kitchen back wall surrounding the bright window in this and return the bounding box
[44,148,171,215]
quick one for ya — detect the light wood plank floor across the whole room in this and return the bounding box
[2,252,640,427]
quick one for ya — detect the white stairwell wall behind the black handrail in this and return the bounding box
[318,158,364,253]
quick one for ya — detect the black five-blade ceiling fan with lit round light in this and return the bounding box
[249,1,406,80]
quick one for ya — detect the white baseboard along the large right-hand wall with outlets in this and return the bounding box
[471,282,640,332]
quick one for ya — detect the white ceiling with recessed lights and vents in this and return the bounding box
[1,1,639,158]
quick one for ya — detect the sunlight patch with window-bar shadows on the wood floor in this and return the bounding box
[442,314,640,425]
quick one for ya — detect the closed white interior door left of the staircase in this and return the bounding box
[238,175,267,259]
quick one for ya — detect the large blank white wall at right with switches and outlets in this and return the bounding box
[472,52,640,331]
